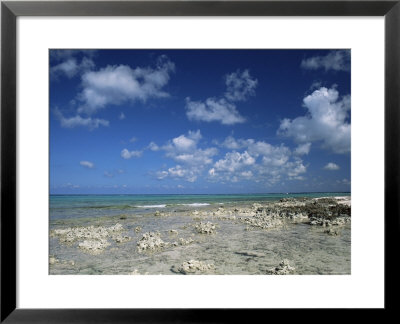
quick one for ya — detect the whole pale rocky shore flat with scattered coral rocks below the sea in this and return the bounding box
[49,197,351,275]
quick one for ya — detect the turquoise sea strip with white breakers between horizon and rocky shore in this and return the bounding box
[49,192,350,220]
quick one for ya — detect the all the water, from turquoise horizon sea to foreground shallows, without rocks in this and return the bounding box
[49,193,351,275]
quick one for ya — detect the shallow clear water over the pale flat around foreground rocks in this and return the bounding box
[50,199,351,275]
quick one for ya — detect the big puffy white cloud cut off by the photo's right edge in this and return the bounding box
[278,87,351,153]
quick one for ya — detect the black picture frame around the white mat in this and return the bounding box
[0,0,400,323]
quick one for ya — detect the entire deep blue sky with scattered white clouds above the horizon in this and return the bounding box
[49,50,351,194]
